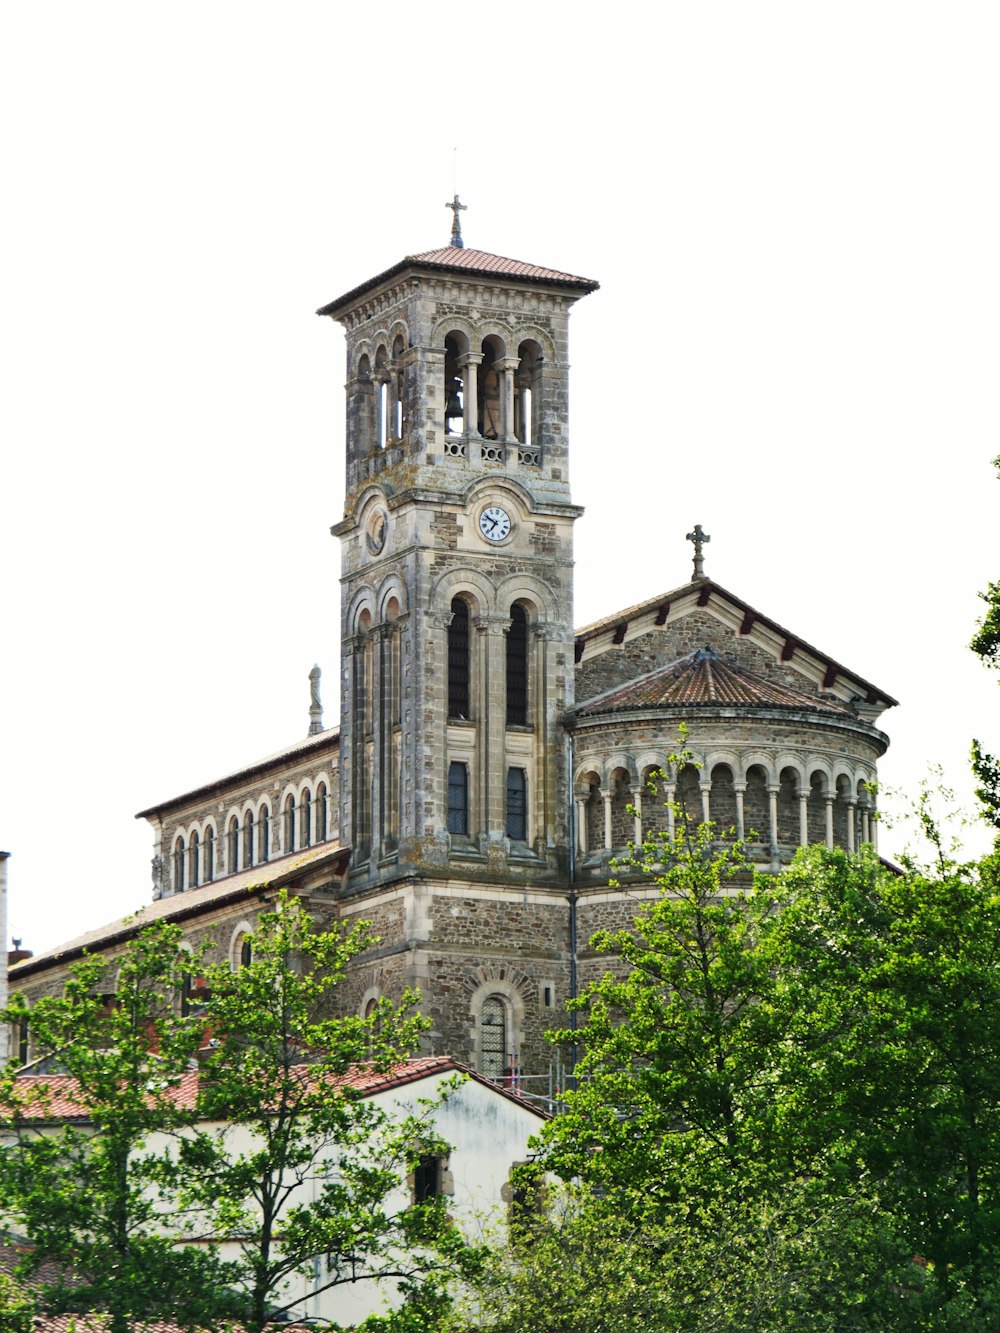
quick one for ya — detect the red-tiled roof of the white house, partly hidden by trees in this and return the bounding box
[1,1056,548,1124]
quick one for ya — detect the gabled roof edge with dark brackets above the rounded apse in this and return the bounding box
[576,579,899,708]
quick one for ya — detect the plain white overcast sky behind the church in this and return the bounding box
[0,0,1000,952]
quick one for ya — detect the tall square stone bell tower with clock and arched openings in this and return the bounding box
[319,218,597,889]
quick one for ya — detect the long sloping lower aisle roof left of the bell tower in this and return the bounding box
[8,842,349,985]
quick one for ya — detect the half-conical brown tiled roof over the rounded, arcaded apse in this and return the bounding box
[576,648,852,717]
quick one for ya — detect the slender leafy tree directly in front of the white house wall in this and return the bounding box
[179,894,468,1333]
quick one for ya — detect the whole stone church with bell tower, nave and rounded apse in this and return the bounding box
[9,213,895,1092]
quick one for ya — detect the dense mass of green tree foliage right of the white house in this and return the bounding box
[477,794,1000,1333]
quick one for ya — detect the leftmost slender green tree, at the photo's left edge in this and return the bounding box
[0,925,234,1333]
